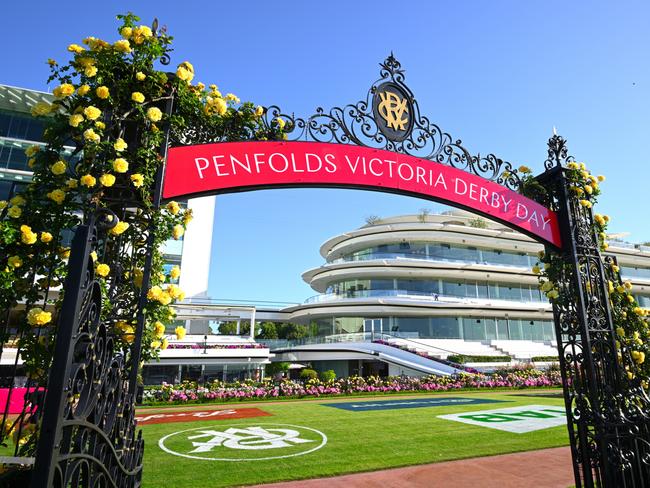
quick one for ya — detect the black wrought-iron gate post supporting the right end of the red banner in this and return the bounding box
[538,135,650,488]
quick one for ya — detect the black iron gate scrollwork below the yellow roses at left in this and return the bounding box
[32,210,144,488]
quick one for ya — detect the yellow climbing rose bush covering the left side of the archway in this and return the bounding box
[0,14,284,454]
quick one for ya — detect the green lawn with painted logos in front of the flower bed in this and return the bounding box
[142,390,568,488]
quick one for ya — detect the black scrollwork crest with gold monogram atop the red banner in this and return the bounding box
[265,54,521,190]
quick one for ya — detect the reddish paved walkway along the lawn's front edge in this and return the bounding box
[257,447,575,488]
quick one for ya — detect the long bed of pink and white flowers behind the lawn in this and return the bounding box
[143,368,562,404]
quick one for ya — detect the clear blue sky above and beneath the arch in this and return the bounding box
[0,0,650,302]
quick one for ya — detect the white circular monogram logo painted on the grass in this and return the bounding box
[158,423,327,461]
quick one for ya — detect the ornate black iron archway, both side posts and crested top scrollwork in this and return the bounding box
[7,51,650,487]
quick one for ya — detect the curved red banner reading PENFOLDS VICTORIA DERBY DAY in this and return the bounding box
[163,142,561,247]
